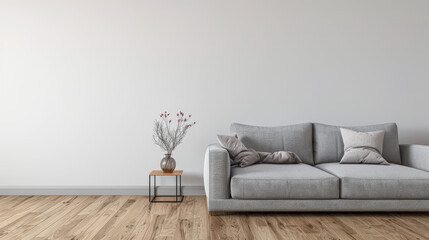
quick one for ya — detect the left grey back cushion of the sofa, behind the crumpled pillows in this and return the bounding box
[230,123,314,165]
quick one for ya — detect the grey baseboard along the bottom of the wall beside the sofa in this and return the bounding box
[0,186,205,196]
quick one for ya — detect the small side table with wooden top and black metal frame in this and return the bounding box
[149,170,184,203]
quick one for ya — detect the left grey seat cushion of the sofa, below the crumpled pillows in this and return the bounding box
[231,163,339,200]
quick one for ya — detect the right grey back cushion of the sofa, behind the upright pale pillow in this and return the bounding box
[313,123,401,164]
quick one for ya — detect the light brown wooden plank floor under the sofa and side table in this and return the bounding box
[0,196,429,240]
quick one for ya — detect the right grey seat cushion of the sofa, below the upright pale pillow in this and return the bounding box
[316,163,429,199]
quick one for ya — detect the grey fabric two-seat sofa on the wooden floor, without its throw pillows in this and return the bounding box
[204,123,429,213]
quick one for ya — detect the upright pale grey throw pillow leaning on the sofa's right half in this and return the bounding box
[340,128,389,165]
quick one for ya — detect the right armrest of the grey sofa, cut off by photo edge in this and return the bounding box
[399,144,429,172]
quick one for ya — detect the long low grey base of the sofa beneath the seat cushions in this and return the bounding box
[208,199,429,214]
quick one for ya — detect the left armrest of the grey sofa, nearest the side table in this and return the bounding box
[204,144,231,203]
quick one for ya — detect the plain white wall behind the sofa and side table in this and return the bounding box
[0,0,429,187]
